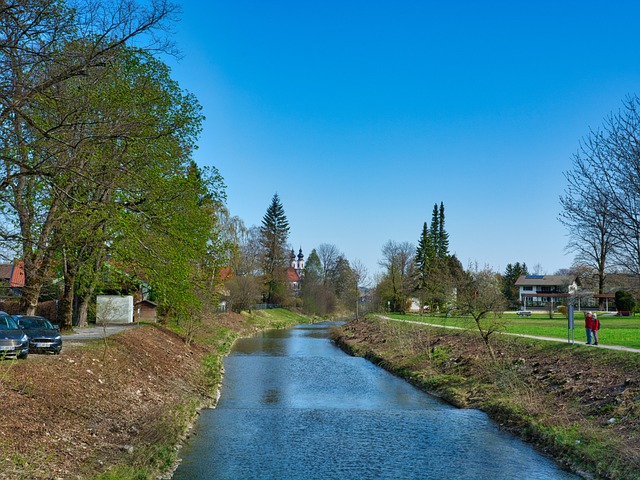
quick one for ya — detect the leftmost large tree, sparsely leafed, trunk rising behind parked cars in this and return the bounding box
[0,0,180,313]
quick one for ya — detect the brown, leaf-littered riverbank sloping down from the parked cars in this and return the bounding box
[0,311,305,480]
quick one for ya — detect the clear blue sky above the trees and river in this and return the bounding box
[162,0,640,274]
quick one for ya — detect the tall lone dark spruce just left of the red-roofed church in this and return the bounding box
[260,193,289,303]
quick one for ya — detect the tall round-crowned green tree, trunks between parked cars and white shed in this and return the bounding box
[56,49,208,327]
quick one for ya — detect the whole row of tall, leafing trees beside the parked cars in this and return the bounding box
[0,0,228,328]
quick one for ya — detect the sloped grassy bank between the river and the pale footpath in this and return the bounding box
[333,317,640,479]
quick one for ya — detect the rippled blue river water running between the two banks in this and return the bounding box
[174,323,579,480]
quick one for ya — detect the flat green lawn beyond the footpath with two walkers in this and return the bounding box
[389,313,640,348]
